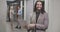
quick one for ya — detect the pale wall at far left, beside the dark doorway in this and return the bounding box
[0,0,7,32]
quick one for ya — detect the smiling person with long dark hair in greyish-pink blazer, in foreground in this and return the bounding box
[27,1,49,32]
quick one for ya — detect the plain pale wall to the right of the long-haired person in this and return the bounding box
[47,0,60,32]
